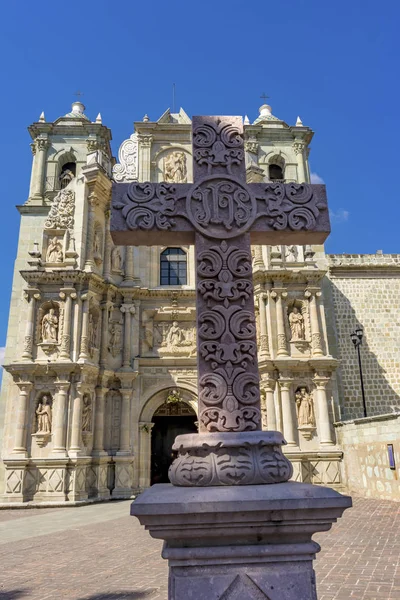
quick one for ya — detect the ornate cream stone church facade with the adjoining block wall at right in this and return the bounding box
[0,102,400,504]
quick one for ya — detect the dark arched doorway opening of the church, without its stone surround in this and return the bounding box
[151,402,197,485]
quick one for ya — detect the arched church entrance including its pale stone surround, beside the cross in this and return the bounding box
[138,386,197,489]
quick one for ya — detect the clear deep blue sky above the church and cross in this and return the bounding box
[0,0,400,360]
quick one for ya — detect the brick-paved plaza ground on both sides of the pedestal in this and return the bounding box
[0,498,400,600]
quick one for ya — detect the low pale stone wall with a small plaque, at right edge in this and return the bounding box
[335,413,400,502]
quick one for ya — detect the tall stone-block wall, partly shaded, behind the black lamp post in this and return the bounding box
[328,254,400,420]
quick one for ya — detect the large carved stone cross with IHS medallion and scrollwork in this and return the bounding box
[111,116,330,433]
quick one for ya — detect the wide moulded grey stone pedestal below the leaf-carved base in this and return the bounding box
[131,482,351,600]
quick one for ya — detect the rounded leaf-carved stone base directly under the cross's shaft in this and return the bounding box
[168,431,293,487]
